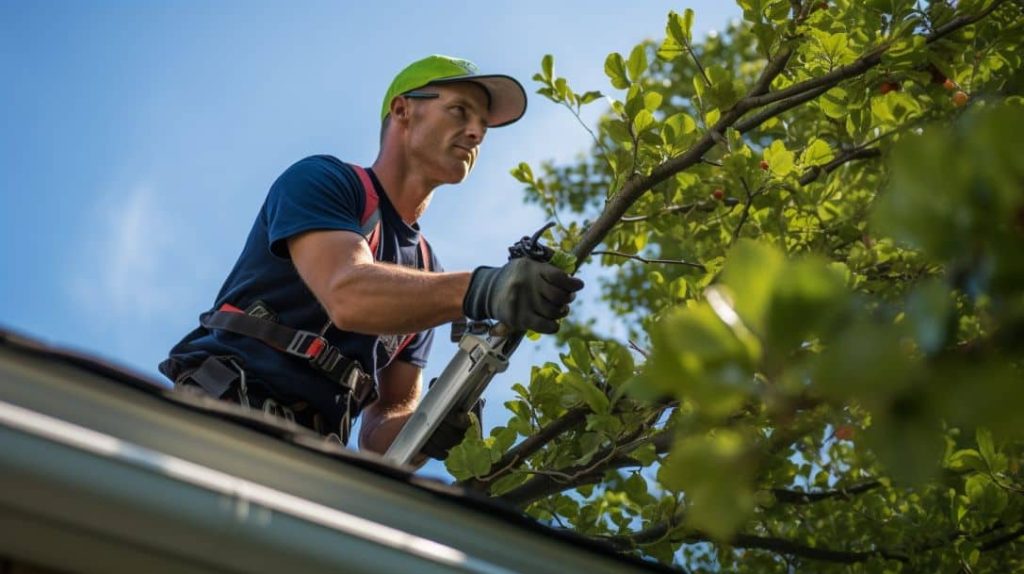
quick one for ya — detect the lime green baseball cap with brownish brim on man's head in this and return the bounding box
[381,54,526,128]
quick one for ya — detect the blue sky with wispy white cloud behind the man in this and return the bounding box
[0,0,738,474]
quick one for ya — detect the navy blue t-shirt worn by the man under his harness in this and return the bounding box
[161,156,441,423]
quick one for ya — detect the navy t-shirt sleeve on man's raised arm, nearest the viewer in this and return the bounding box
[265,156,366,259]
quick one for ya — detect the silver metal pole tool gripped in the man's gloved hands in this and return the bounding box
[384,223,575,465]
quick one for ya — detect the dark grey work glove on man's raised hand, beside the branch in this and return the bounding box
[462,257,583,334]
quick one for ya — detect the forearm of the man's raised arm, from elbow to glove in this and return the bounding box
[322,263,471,335]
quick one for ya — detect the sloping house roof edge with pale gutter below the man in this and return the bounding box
[0,329,667,574]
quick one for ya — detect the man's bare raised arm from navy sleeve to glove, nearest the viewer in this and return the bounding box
[288,230,471,335]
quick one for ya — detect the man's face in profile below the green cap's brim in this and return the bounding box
[408,82,487,183]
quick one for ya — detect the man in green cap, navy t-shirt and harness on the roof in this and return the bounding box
[160,55,583,457]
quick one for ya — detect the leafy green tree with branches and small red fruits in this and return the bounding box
[449,0,1024,572]
